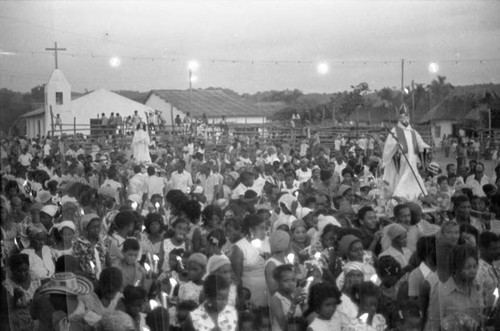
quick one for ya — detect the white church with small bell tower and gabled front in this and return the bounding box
[22,69,153,138]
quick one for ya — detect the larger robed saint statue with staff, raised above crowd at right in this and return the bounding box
[382,104,429,200]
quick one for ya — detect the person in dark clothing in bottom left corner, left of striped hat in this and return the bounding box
[2,254,41,331]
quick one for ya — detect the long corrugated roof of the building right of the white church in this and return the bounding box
[151,90,266,118]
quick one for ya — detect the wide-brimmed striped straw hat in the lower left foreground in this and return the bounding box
[40,272,94,295]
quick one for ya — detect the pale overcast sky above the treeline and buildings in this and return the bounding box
[0,0,500,93]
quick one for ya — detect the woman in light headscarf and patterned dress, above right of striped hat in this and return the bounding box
[73,214,106,281]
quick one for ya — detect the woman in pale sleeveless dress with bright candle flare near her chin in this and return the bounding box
[230,214,270,307]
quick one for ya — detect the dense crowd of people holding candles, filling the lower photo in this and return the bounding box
[0,123,500,331]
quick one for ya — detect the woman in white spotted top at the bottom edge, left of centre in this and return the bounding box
[184,275,238,331]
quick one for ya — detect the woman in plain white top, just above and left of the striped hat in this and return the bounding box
[21,223,55,280]
